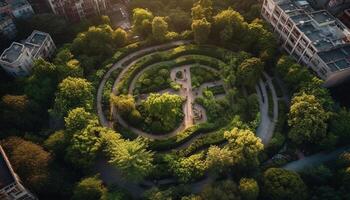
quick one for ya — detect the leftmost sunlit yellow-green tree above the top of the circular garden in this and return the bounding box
[132,8,153,36]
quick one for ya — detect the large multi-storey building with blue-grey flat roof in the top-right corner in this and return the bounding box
[261,0,350,87]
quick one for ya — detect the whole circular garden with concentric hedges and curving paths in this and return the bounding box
[97,41,278,153]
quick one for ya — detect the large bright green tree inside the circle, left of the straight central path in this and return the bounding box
[142,93,183,131]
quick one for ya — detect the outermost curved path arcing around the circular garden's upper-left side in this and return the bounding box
[96,40,191,127]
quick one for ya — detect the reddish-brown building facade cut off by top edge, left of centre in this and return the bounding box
[48,0,108,21]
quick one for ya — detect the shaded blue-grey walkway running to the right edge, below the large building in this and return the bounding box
[282,146,350,172]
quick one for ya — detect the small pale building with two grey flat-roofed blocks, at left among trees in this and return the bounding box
[0,31,56,77]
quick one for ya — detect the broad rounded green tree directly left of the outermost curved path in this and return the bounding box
[54,77,93,116]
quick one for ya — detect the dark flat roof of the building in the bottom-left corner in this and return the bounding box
[0,146,15,189]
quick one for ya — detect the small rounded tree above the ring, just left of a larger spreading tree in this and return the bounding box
[191,18,211,44]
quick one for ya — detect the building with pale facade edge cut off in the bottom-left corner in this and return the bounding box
[0,146,37,200]
